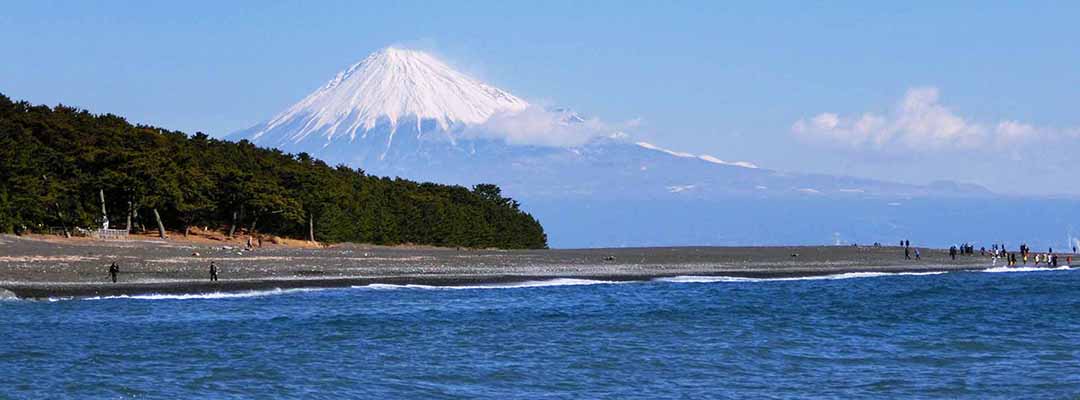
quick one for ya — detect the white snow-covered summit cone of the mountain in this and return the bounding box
[251,48,528,143]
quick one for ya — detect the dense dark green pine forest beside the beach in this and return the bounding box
[0,94,546,249]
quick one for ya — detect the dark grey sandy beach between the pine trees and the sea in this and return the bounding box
[0,232,991,298]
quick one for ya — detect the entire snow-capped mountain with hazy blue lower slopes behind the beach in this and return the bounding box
[228,48,1080,248]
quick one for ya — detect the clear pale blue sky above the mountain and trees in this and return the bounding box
[0,1,1080,195]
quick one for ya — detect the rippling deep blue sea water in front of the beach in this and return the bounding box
[0,268,1080,399]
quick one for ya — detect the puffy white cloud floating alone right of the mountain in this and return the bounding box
[792,86,1070,150]
